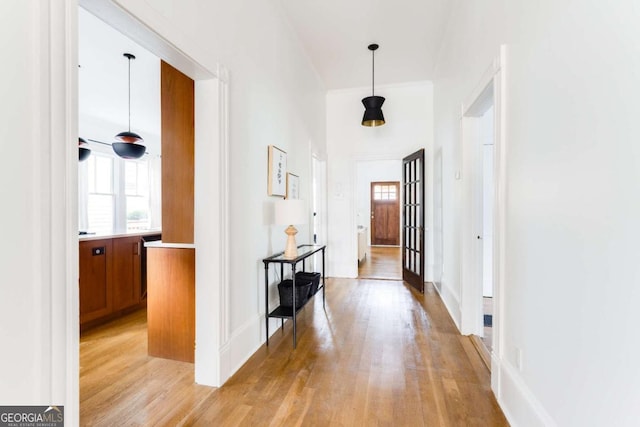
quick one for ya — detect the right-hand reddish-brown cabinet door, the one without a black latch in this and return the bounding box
[111,236,141,311]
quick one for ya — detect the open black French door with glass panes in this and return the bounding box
[402,150,425,293]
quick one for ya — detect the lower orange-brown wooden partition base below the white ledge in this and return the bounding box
[147,248,196,363]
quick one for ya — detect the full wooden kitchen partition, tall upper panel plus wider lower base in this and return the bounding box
[147,61,195,362]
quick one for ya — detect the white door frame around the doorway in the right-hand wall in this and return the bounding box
[460,46,507,390]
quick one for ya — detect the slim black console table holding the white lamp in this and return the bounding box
[262,245,326,348]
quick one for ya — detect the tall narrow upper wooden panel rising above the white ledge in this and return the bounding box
[160,61,195,243]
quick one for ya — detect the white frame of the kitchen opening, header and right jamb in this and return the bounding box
[78,0,232,386]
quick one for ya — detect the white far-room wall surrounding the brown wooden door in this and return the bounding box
[356,160,402,245]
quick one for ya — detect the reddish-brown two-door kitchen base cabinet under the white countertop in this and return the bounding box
[79,236,141,330]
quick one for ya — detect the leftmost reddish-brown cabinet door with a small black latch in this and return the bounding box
[79,239,112,323]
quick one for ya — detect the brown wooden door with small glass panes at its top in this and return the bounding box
[371,181,400,246]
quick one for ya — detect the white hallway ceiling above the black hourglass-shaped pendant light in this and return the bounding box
[276,0,451,89]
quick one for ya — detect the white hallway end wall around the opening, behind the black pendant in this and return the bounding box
[327,82,433,280]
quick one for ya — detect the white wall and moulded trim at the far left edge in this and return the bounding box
[0,0,79,425]
